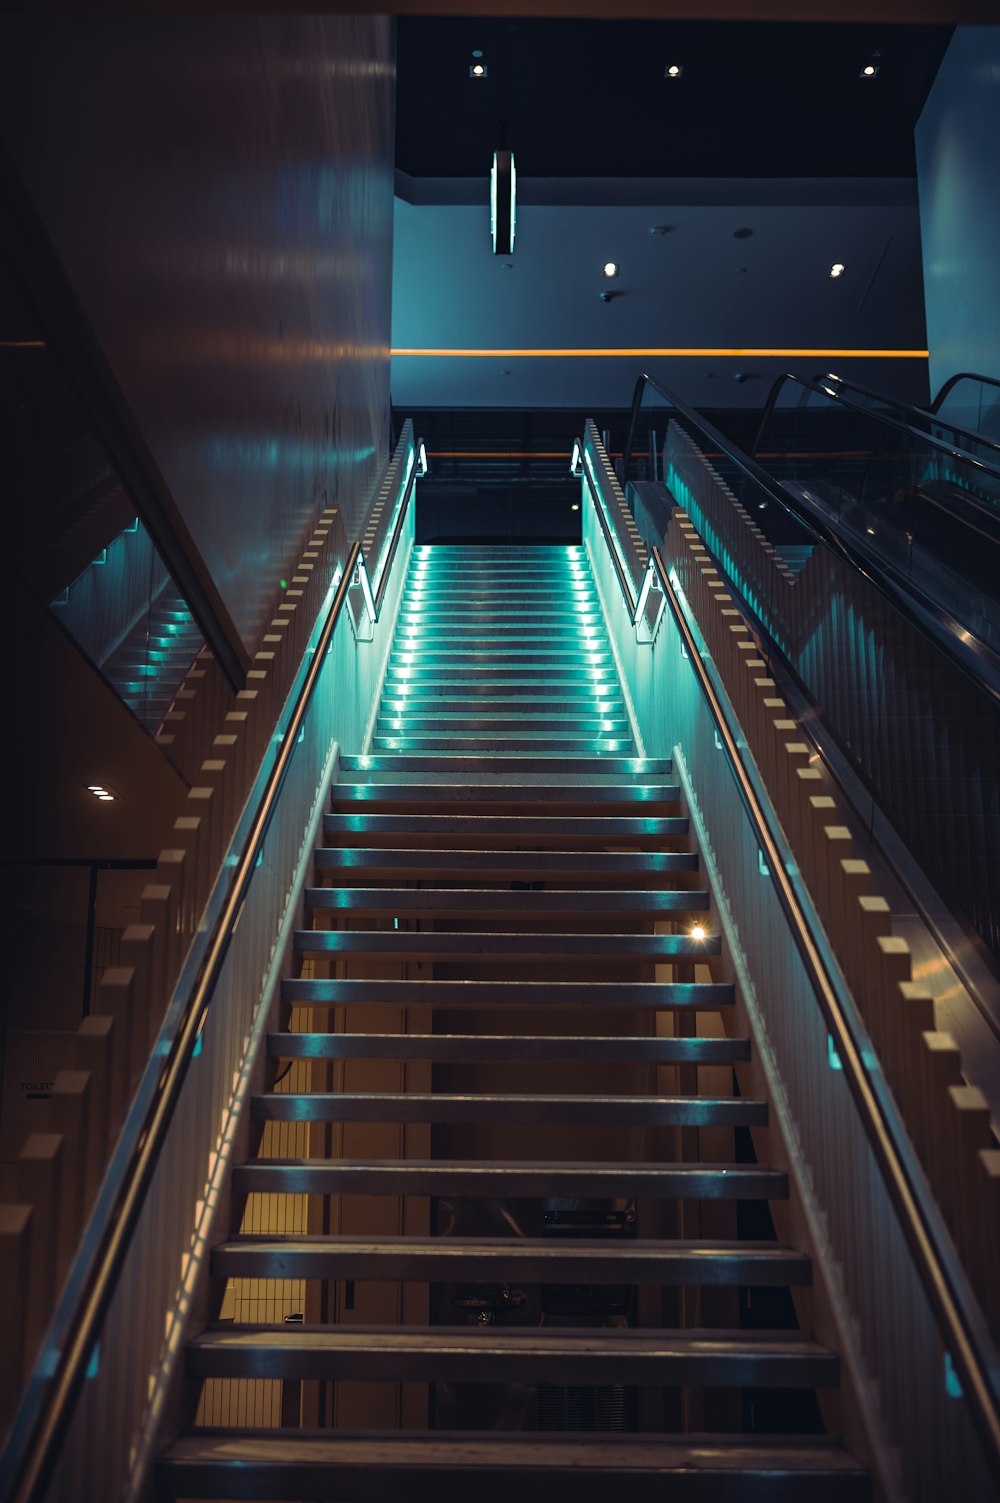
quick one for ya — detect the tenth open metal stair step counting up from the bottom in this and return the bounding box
[314,846,699,882]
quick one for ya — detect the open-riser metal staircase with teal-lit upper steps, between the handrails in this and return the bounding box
[156,547,869,1503]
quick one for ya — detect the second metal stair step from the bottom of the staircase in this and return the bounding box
[186,1324,839,1389]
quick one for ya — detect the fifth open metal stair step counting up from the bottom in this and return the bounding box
[250,1091,767,1127]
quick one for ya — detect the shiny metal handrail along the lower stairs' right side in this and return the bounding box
[651,547,1000,1480]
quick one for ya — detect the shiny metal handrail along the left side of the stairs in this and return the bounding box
[6,438,415,1503]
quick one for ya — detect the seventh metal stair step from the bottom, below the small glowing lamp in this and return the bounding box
[281,973,735,1012]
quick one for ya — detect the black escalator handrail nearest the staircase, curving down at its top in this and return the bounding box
[623,373,1000,705]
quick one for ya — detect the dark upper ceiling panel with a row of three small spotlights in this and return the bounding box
[395,17,952,177]
